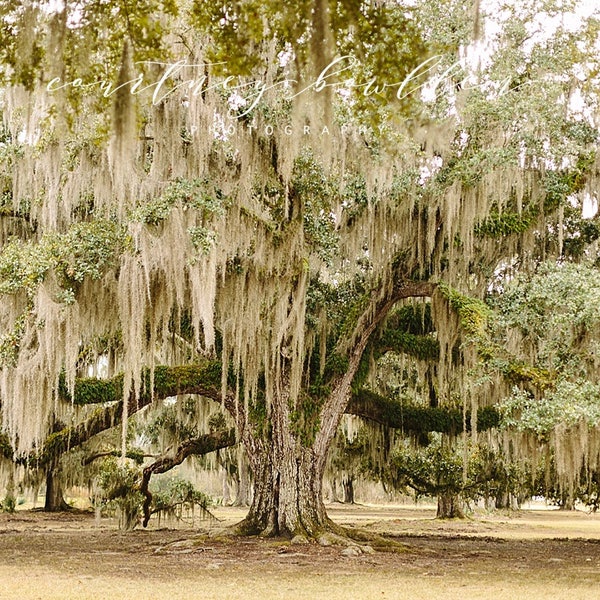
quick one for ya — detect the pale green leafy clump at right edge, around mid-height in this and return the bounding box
[495,263,600,439]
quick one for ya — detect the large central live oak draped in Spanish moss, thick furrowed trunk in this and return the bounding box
[0,0,597,536]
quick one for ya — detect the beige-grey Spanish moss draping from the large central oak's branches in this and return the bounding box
[0,0,598,531]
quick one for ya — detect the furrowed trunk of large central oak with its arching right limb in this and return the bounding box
[232,280,434,538]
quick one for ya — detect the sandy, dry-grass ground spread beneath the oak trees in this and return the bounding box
[0,505,600,600]
